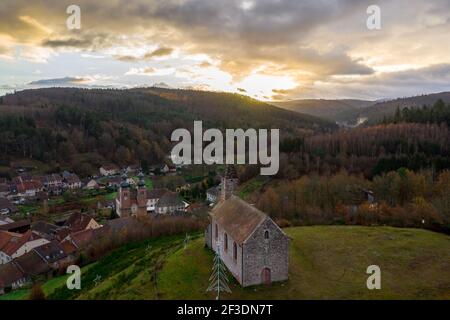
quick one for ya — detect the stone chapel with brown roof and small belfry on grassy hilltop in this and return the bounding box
[205,167,289,287]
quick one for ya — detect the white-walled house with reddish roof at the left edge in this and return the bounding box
[0,230,50,264]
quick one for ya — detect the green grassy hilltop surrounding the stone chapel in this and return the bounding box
[4,226,450,299]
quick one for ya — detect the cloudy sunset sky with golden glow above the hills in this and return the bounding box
[0,0,450,100]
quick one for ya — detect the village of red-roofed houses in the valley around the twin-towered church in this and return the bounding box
[0,164,232,294]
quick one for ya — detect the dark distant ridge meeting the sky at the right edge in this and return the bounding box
[336,92,450,124]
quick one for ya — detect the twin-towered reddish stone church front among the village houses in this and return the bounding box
[116,173,147,217]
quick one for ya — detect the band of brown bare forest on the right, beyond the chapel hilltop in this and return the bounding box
[270,123,450,178]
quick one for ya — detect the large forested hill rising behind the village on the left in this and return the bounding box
[0,88,335,175]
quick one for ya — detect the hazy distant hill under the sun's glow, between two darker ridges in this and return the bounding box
[272,99,375,121]
